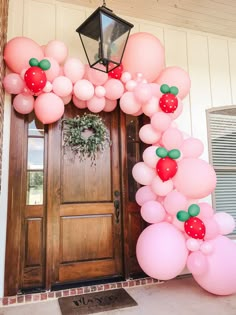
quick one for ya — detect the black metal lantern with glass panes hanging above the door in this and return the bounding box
[76,1,133,72]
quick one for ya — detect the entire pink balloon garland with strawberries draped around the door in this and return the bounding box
[3,33,236,295]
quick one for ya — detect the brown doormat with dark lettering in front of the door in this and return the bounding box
[58,289,138,315]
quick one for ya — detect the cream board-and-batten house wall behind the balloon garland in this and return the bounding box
[0,0,236,296]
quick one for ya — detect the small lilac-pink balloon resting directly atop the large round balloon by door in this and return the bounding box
[141,200,166,223]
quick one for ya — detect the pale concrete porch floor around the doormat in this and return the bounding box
[0,277,236,315]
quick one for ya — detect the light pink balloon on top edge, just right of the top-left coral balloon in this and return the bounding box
[44,40,68,64]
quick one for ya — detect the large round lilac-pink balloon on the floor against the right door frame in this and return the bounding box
[136,222,188,280]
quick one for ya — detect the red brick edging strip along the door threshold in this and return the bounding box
[0,278,163,307]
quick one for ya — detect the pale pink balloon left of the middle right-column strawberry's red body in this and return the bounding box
[132,162,156,185]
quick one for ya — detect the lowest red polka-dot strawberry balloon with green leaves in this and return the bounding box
[176,204,206,240]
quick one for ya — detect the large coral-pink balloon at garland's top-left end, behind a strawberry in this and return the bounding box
[4,37,44,74]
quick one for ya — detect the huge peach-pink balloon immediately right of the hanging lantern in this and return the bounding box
[122,32,165,82]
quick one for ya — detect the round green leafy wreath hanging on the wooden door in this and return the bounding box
[62,113,111,163]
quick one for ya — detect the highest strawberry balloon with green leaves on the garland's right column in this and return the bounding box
[159,84,179,114]
